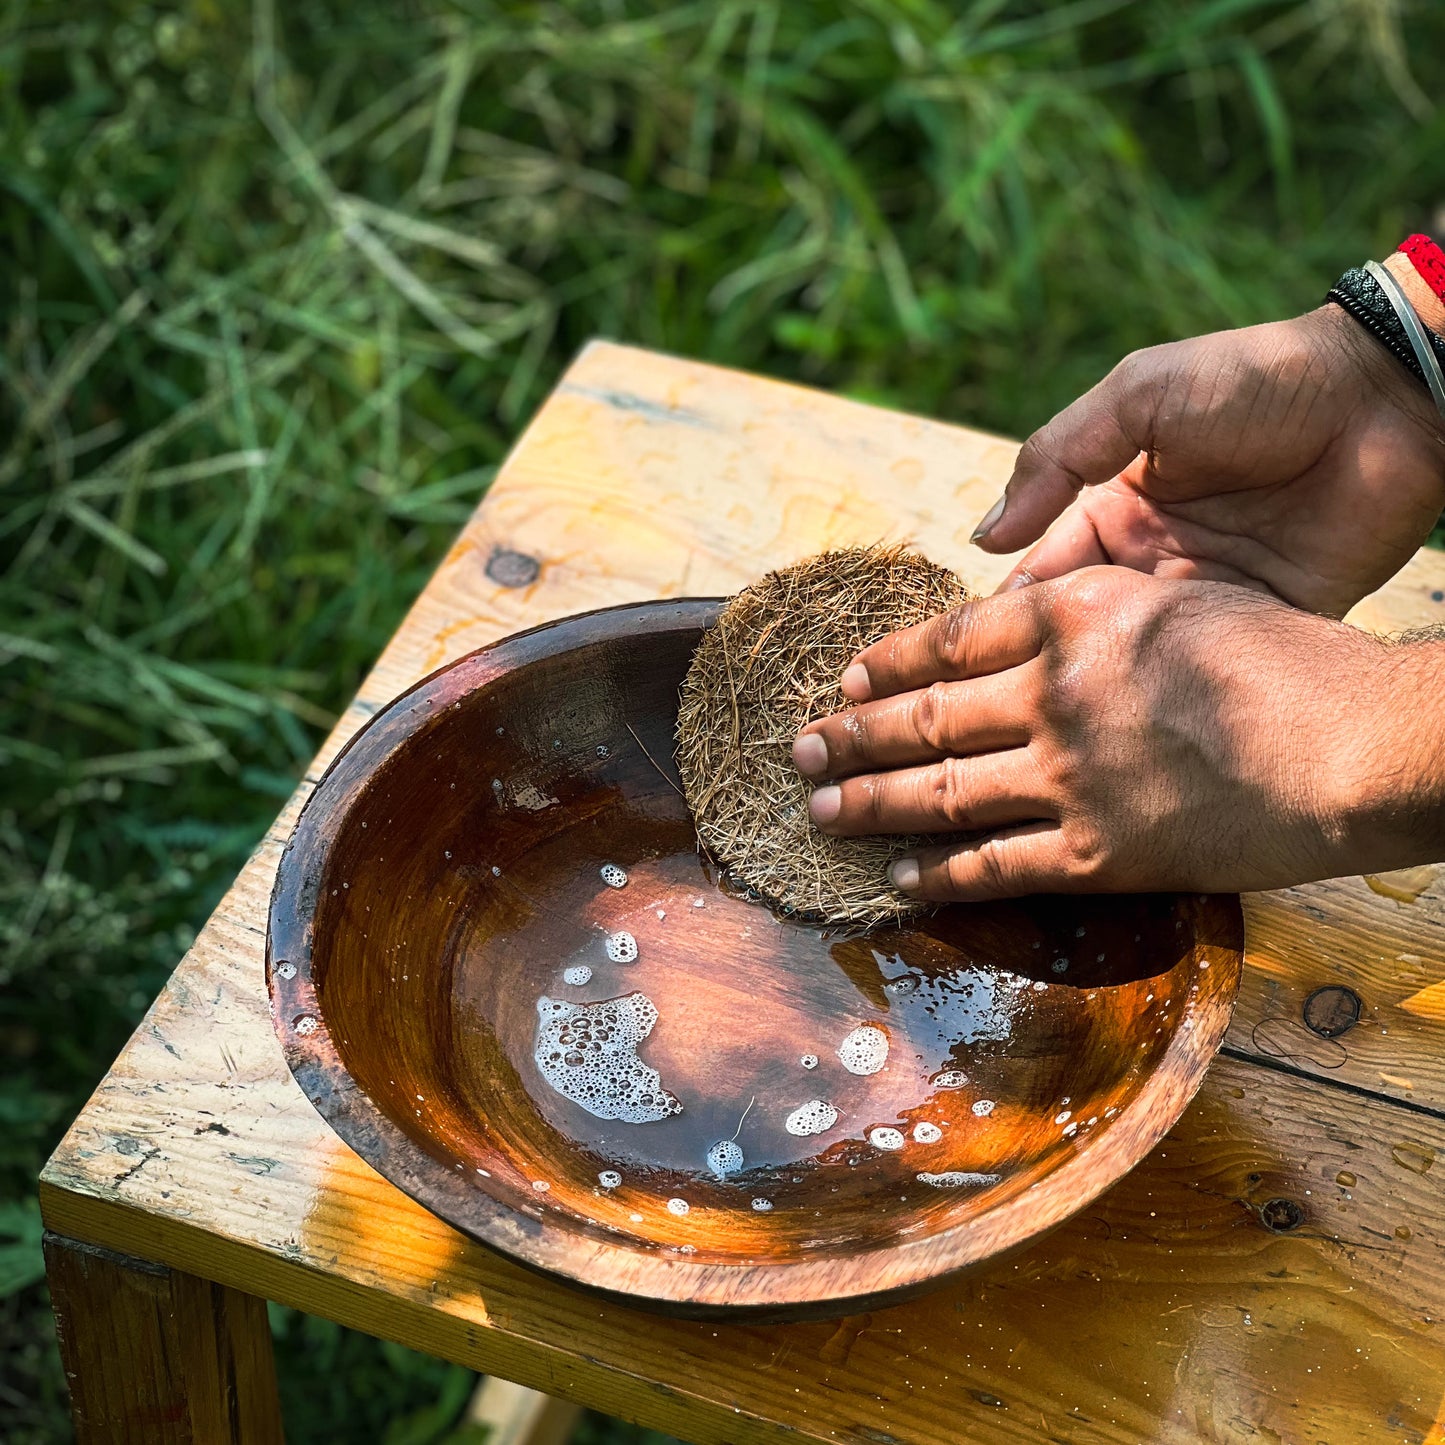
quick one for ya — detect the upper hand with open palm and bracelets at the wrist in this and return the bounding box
[975,302,1445,617]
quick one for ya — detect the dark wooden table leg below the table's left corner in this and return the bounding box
[45,1234,283,1445]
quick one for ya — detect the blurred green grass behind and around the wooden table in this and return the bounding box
[0,0,1445,1445]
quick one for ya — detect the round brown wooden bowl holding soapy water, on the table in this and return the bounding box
[267,601,1243,1318]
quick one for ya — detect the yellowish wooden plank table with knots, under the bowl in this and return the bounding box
[40,344,1445,1445]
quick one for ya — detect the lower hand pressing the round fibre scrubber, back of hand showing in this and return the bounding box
[793,566,1445,900]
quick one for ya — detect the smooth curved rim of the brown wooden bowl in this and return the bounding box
[266,598,1244,1318]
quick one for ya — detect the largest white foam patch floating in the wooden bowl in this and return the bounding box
[532,993,682,1124]
